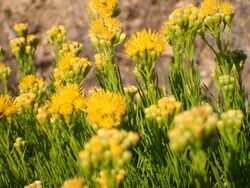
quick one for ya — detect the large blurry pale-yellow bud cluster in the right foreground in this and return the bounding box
[168,105,218,152]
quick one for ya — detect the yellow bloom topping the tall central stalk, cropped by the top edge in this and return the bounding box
[89,0,117,17]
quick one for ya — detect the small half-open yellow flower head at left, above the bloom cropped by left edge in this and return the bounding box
[19,74,45,93]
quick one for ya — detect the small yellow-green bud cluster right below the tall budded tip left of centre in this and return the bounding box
[60,41,83,57]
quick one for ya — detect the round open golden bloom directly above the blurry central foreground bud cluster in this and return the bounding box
[86,90,126,129]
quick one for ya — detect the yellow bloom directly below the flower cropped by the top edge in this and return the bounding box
[89,17,122,41]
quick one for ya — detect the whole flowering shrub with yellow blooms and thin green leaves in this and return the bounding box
[0,0,250,188]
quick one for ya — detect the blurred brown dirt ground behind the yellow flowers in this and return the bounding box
[0,0,250,90]
